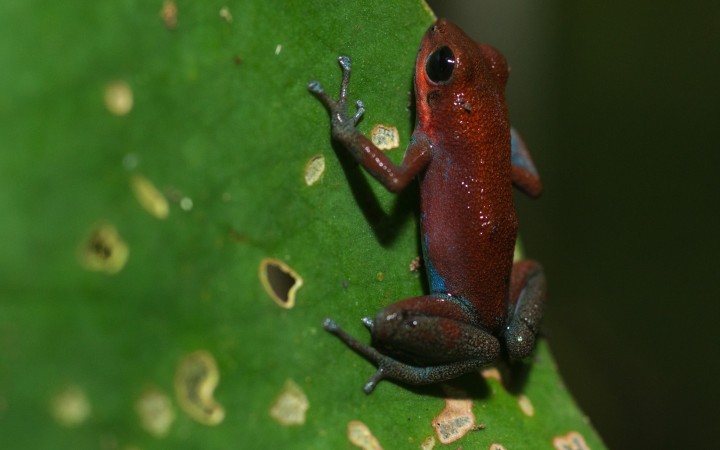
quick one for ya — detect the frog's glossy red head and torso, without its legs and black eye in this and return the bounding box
[416,23,517,331]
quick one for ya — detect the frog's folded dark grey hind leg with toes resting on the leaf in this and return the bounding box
[324,295,500,394]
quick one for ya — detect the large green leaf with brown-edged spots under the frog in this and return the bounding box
[0,0,602,449]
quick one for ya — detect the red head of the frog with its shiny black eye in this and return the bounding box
[415,19,509,131]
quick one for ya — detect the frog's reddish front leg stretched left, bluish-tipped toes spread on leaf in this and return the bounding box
[308,56,432,192]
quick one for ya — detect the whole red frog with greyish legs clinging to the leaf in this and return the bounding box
[308,20,545,394]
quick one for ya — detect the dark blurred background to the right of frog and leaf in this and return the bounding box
[430,0,720,449]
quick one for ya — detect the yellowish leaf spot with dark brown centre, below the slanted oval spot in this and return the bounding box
[79,223,130,274]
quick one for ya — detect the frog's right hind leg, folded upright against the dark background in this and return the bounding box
[503,259,545,361]
